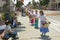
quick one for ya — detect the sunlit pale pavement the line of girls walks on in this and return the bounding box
[9,12,60,40]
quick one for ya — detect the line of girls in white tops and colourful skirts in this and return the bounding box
[28,10,50,35]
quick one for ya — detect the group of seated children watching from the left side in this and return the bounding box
[0,15,18,40]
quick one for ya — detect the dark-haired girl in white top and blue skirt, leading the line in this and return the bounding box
[40,11,49,36]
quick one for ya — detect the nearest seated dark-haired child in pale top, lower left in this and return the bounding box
[3,20,18,40]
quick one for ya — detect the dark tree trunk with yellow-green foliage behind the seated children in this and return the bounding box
[2,0,13,21]
